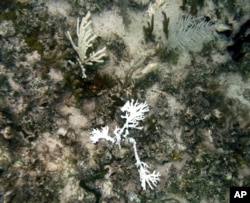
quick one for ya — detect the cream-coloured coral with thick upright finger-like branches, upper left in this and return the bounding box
[67,12,106,78]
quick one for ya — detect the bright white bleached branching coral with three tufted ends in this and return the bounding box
[90,99,160,190]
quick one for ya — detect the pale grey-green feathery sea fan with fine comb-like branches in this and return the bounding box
[166,15,214,51]
